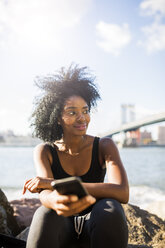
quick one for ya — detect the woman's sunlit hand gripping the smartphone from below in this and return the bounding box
[50,190,96,217]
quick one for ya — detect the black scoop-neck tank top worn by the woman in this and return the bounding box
[49,137,106,183]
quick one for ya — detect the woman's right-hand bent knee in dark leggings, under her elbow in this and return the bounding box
[90,198,128,247]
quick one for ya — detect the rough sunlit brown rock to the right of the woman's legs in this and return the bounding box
[123,204,165,248]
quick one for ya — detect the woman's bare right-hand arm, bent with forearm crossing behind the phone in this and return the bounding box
[84,138,129,203]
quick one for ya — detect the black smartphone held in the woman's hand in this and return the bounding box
[51,177,88,198]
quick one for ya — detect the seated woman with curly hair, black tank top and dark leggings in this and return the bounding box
[23,66,129,248]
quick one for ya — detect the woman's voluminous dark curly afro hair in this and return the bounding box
[31,65,100,143]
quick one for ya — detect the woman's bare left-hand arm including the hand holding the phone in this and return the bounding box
[23,144,95,216]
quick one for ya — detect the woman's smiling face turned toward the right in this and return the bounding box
[60,96,90,138]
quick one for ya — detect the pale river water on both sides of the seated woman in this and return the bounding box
[0,147,165,213]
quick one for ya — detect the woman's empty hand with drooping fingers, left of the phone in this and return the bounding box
[22,176,54,194]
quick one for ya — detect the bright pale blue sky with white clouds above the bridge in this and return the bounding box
[0,0,165,138]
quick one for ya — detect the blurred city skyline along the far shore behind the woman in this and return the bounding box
[0,121,165,148]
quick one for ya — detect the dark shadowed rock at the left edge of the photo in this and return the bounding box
[0,189,20,236]
